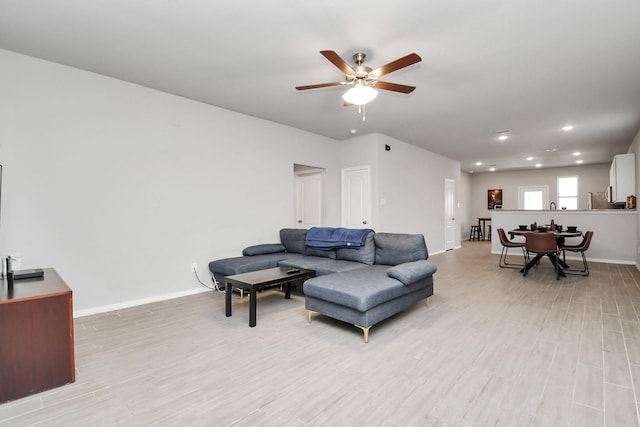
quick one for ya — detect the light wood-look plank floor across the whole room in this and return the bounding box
[0,241,640,427]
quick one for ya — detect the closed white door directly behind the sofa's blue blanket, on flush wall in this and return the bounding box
[342,166,373,228]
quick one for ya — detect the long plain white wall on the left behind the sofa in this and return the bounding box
[0,50,339,311]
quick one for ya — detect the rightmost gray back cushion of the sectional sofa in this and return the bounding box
[373,233,429,265]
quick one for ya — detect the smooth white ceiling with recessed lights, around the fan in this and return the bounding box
[0,0,640,173]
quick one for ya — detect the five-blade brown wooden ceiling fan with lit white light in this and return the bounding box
[296,50,422,105]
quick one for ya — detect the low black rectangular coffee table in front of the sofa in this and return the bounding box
[224,267,316,327]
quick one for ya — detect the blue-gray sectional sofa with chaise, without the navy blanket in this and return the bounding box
[209,228,436,342]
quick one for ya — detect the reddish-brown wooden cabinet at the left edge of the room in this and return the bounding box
[0,268,75,403]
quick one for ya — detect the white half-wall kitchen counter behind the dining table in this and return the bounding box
[491,209,638,265]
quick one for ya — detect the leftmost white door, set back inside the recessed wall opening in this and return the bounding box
[296,171,324,228]
